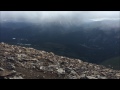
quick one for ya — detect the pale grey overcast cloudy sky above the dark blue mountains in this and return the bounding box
[0,11,120,22]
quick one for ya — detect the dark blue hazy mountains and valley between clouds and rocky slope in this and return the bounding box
[0,20,120,69]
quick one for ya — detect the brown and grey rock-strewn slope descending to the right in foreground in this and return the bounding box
[0,42,120,79]
